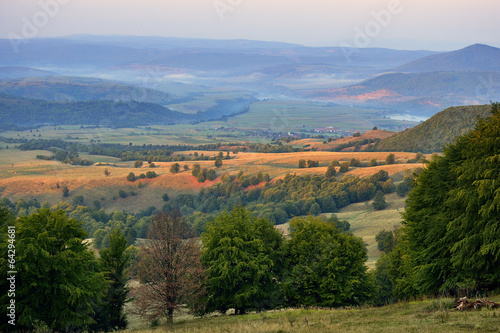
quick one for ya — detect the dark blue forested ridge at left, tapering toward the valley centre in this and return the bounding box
[0,93,254,129]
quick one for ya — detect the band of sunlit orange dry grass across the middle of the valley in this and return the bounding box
[0,149,418,212]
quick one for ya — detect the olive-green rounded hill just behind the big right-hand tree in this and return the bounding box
[376,105,491,153]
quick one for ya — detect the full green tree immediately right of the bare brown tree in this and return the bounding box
[202,206,283,314]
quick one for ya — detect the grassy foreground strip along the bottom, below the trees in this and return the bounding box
[122,296,500,333]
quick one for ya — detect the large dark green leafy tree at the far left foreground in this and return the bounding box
[0,209,107,332]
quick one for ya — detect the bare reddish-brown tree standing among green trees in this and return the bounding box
[132,211,205,323]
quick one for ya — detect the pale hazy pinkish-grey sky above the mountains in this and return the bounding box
[0,0,500,50]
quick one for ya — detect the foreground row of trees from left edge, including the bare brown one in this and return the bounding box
[0,206,372,332]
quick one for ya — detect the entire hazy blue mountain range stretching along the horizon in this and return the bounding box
[0,35,500,117]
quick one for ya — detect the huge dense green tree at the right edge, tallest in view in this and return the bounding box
[404,103,500,294]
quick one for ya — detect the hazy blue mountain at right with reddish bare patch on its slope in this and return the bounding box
[309,44,500,116]
